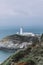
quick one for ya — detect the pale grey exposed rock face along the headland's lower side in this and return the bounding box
[0,41,32,49]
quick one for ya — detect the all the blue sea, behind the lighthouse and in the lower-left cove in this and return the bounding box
[0,27,43,63]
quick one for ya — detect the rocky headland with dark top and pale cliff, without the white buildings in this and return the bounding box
[0,34,38,49]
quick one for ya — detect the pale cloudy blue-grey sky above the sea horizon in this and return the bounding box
[0,0,43,28]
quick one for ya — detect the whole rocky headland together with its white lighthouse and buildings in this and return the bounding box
[0,28,41,50]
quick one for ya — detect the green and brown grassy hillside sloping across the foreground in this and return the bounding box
[1,42,43,65]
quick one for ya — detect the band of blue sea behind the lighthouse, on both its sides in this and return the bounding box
[0,27,43,39]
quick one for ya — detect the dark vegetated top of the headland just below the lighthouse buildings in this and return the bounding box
[2,34,38,43]
